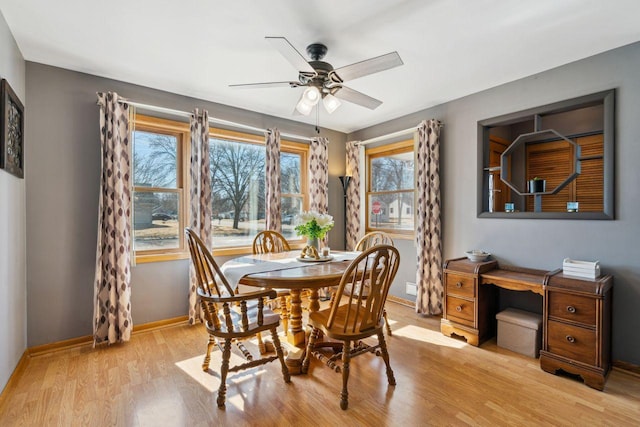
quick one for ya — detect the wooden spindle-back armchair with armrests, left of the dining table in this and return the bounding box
[185,228,291,408]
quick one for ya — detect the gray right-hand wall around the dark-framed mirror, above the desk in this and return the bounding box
[348,43,640,365]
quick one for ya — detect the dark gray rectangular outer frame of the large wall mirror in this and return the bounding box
[477,89,615,220]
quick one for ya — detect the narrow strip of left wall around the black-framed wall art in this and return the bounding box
[0,13,30,391]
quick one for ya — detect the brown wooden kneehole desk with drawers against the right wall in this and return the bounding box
[440,258,613,390]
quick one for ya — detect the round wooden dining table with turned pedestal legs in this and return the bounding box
[223,251,355,373]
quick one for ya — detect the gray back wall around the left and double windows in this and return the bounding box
[25,62,345,346]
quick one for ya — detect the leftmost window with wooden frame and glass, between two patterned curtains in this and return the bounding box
[133,115,189,257]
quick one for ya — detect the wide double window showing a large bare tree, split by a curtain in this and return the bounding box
[210,129,308,253]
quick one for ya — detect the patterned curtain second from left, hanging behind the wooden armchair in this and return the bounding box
[189,108,212,325]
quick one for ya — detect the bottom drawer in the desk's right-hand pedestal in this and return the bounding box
[547,320,597,365]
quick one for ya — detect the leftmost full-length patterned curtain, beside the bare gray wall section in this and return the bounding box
[93,92,133,346]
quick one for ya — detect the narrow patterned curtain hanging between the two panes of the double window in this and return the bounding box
[265,129,282,232]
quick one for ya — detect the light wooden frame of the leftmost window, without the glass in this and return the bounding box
[131,114,191,264]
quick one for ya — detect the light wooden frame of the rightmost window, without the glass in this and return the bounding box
[364,138,416,240]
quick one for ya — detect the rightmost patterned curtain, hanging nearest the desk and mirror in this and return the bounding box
[416,119,443,315]
